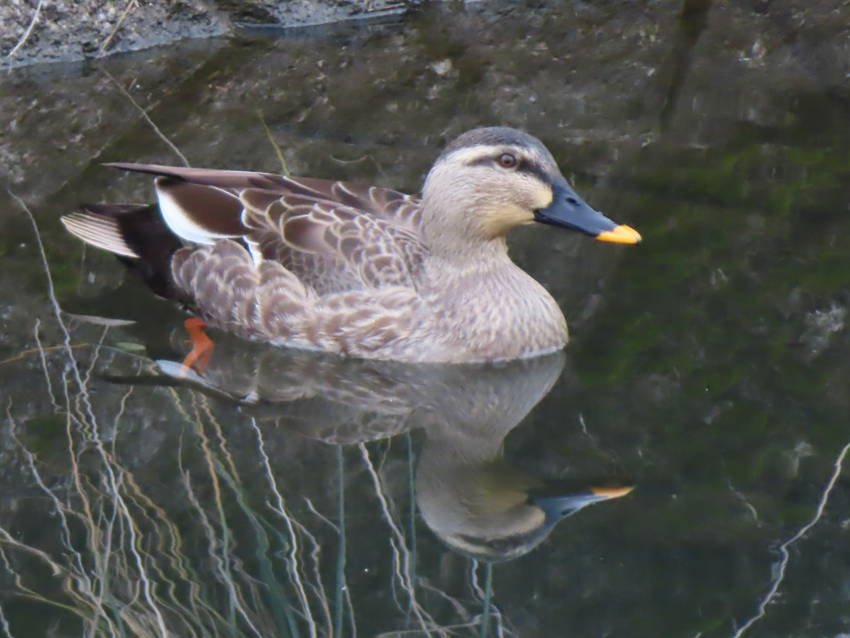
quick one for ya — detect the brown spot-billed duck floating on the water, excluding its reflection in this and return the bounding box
[61,127,641,363]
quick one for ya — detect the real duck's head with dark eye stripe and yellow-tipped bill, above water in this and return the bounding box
[422,127,641,250]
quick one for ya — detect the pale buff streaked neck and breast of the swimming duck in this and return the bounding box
[419,181,567,361]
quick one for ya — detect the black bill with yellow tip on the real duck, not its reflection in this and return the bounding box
[534,183,641,244]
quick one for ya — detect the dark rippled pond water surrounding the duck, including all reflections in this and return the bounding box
[0,2,850,638]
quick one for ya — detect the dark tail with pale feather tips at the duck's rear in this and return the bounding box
[61,204,183,297]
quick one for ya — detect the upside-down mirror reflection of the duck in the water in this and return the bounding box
[151,339,632,561]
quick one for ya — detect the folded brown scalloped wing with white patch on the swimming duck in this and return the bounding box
[104,163,428,296]
